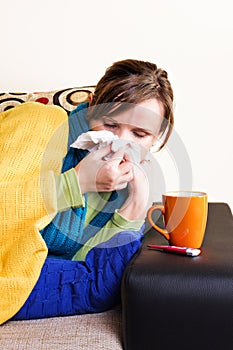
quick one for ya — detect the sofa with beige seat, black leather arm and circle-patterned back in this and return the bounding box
[0,86,233,350]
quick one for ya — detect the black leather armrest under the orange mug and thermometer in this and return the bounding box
[122,203,233,350]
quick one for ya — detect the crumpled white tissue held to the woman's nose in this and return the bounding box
[70,130,150,164]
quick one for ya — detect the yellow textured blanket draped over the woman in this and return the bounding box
[0,102,68,324]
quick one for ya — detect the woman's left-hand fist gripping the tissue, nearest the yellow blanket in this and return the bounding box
[75,146,134,194]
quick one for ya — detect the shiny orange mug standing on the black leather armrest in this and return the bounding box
[147,191,208,248]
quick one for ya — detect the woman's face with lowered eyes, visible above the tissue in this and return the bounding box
[90,98,164,149]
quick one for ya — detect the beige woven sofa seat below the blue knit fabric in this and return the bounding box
[0,308,122,350]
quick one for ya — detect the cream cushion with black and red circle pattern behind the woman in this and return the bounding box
[0,86,95,113]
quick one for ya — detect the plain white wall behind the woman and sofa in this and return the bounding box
[0,0,233,207]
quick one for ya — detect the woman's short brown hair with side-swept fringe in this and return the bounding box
[89,59,174,148]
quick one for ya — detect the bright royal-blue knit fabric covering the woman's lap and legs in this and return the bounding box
[12,228,143,320]
